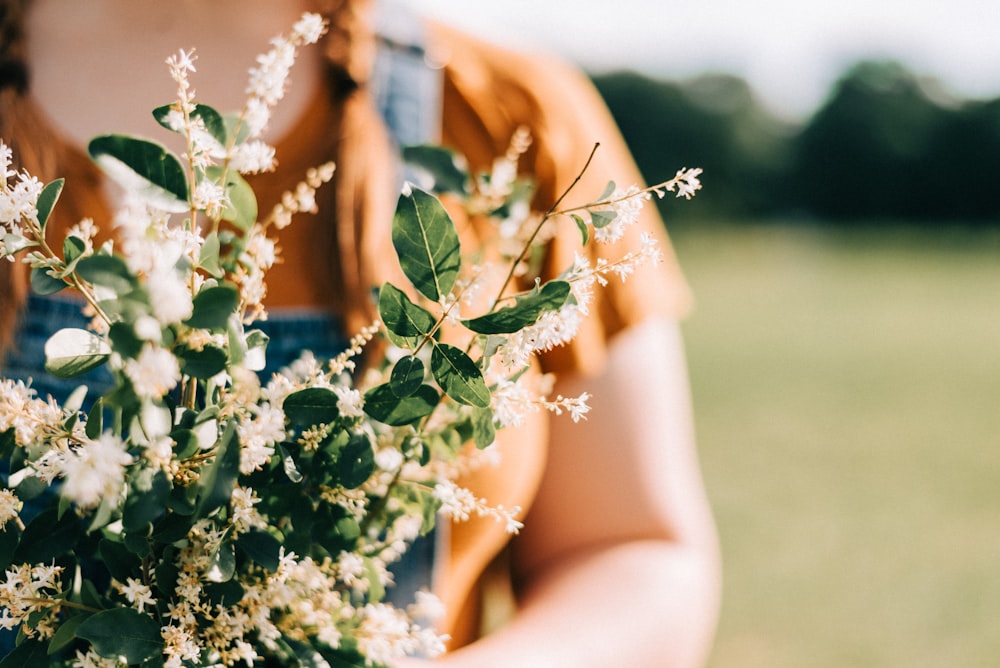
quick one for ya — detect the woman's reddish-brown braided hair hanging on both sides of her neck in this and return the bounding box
[0,0,392,359]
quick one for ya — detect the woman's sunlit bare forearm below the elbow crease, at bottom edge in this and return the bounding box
[430,540,719,668]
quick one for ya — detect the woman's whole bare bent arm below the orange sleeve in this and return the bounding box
[404,318,719,668]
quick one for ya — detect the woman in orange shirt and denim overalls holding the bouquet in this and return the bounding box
[0,0,718,668]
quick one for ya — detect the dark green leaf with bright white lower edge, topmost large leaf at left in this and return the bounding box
[87,135,188,213]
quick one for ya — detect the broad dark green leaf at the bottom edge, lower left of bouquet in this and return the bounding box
[76,608,163,663]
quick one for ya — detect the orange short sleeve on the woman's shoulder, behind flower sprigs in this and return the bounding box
[435,26,690,373]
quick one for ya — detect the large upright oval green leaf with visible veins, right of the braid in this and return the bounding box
[392,188,462,302]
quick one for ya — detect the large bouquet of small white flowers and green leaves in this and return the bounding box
[0,10,700,666]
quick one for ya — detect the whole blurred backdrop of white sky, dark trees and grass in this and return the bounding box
[415,0,1000,668]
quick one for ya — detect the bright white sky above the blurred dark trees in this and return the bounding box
[411,0,1000,119]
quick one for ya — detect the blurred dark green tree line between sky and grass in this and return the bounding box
[593,61,1000,225]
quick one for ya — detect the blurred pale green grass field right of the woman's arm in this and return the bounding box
[674,226,1000,668]
